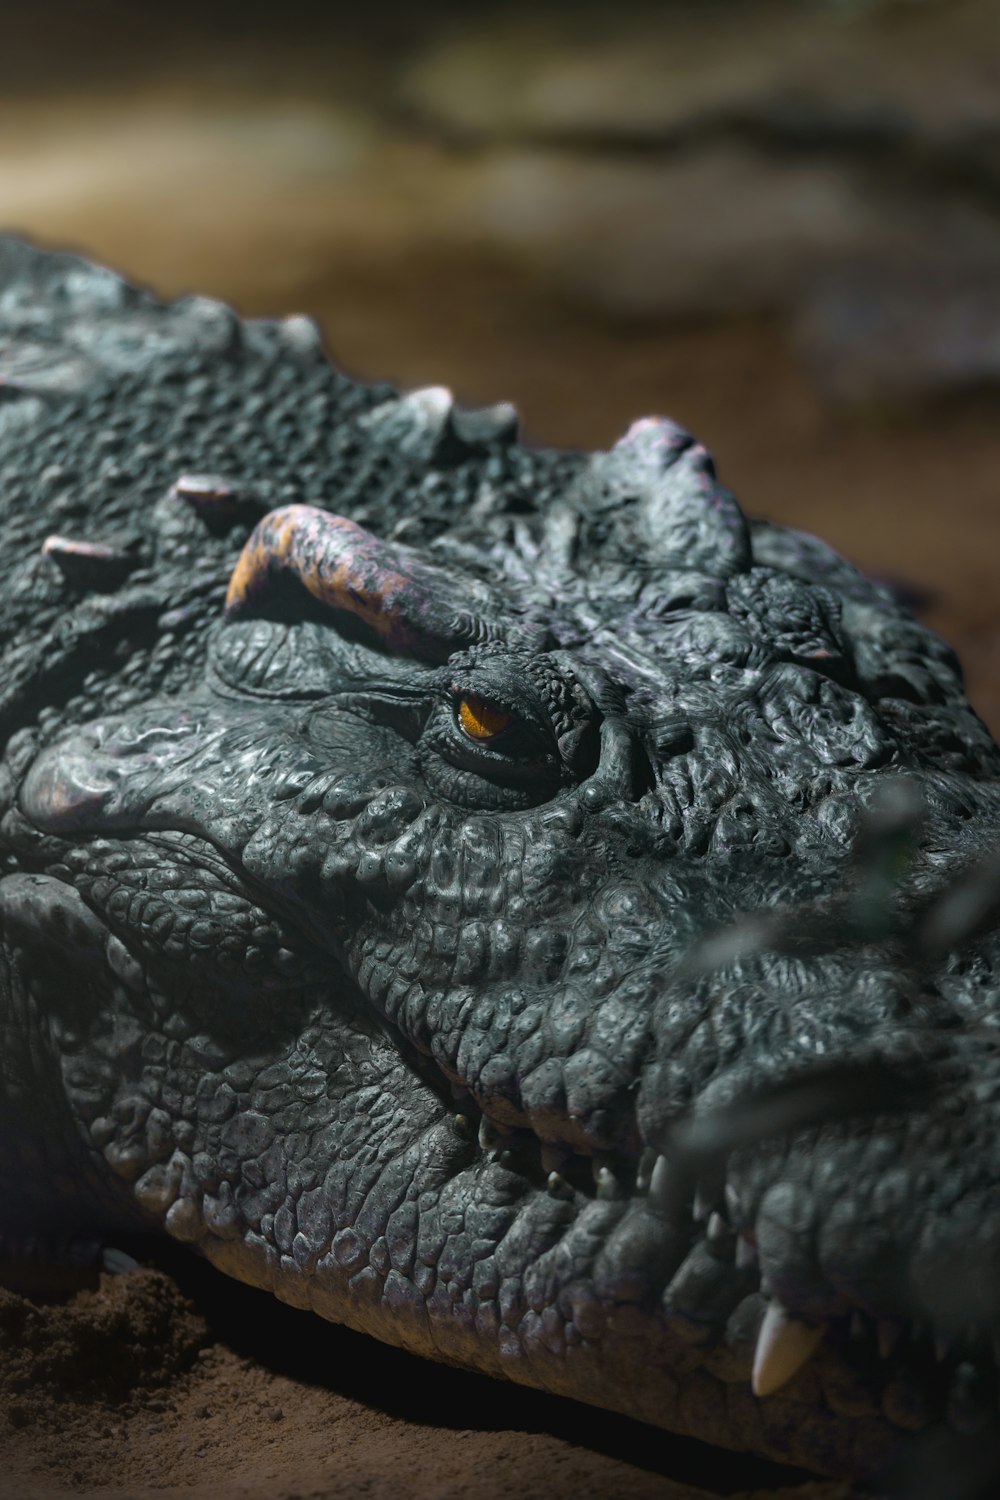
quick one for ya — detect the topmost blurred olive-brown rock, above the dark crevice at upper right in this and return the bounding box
[399,0,1000,150]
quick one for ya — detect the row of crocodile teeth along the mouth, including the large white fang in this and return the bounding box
[456,1115,1000,1397]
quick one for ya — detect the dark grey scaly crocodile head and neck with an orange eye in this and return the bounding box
[0,242,1000,1475]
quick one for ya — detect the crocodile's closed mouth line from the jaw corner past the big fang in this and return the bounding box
[18,830,1000,1433]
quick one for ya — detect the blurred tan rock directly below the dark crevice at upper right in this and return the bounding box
[448,144,1000,324]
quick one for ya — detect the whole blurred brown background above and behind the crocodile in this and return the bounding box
[0,0,1000,731]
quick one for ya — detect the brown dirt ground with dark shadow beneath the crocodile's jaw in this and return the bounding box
[0,1262,850,1500]
